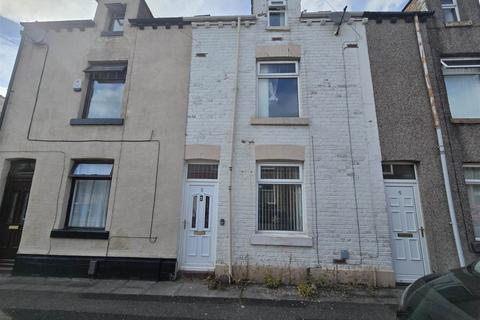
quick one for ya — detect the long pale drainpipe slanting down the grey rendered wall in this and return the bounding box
[414,15,465,267]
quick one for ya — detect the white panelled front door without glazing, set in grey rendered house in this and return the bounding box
[385,181,429,283]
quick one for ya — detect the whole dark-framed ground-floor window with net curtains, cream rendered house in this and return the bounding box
[67,162,113,229]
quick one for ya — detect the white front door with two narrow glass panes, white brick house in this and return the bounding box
[181,183,217,271]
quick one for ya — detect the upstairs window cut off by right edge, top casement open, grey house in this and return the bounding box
[441,58,480,119]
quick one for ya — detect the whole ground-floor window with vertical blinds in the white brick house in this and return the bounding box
[257,164,304,232]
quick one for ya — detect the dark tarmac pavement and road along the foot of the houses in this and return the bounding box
[0,276,402,320]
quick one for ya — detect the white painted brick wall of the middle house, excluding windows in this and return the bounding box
[186,0,392,271]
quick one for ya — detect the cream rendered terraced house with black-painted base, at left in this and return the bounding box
[0,0,192,280]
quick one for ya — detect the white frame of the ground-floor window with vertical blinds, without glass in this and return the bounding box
[255,162,307,236]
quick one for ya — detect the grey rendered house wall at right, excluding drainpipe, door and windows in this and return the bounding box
[367,0,480,278]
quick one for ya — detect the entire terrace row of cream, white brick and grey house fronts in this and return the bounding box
[0,0,480,286]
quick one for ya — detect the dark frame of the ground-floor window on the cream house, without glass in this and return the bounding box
[64,159,115,231]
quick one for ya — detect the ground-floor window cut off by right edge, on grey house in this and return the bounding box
[464,165,480,241]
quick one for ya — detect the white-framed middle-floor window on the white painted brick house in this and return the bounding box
[257,61,300,118]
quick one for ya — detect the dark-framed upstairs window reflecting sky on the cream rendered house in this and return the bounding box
[83,64,127,119]
